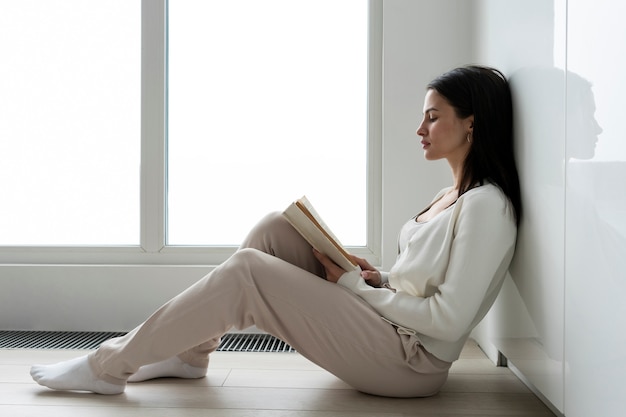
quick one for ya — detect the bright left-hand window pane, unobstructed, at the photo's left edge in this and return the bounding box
[0,0,141,245]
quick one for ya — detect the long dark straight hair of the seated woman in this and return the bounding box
[428,65,522,225]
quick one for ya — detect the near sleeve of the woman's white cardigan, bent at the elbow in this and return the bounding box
[339,187,516,342]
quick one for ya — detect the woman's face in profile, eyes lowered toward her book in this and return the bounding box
[417,89,474,164]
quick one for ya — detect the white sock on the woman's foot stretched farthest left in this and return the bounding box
[30,356,126,394]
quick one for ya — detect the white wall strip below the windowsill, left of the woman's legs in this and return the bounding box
[0,265,209,331]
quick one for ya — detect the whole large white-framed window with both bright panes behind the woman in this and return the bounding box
[0,0,382,264]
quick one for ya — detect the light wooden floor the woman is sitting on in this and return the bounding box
[0,342,554,417]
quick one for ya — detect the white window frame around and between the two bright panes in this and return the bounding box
[0,0,383,265]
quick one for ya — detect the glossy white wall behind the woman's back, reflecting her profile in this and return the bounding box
[475,0,626,417]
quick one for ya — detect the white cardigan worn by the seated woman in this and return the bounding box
[338,183,517,362]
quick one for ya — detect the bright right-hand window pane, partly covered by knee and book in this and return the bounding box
[167,0,368,246]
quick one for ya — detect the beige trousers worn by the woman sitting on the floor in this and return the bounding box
[89,213,450,397]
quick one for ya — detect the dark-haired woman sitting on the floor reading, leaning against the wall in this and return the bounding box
[31,66,521,397]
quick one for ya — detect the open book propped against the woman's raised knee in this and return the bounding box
[283,196,359,271]
